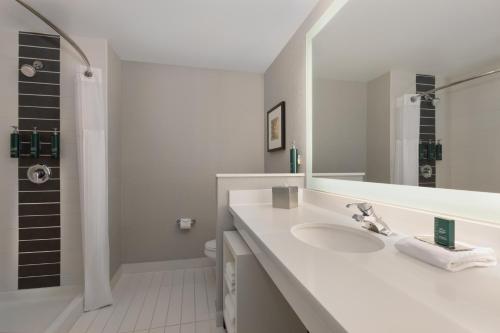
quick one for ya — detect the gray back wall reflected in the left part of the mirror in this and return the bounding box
[313,78,367,172]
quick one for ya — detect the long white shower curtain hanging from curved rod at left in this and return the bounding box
[75,66,113,311]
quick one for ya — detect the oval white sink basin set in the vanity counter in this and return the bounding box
[291,223,385,253]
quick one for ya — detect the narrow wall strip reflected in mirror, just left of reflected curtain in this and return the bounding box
[366,73,391,183]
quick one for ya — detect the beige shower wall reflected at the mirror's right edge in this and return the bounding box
[443,62,500,193]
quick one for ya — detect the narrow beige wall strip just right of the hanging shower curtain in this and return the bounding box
[107,45,122,276]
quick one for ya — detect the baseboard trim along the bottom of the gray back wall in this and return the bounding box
[120,257,215,274]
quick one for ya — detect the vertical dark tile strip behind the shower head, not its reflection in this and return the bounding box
[18,32,61,289]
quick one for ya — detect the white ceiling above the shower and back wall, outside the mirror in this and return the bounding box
[0,0,318,73]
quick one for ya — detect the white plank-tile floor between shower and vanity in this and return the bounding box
[70,267,224,333]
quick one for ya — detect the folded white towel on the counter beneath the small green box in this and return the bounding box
[395,237,497,272]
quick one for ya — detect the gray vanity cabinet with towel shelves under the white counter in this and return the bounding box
[223,231,307,333]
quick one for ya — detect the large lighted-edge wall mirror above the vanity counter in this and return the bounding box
[307,0,500,221]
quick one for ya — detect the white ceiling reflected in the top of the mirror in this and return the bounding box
[313,0,500,82]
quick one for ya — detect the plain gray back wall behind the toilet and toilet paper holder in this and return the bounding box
[121,62,264,262]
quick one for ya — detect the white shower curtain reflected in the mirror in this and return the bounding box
[393,95,420,186]
